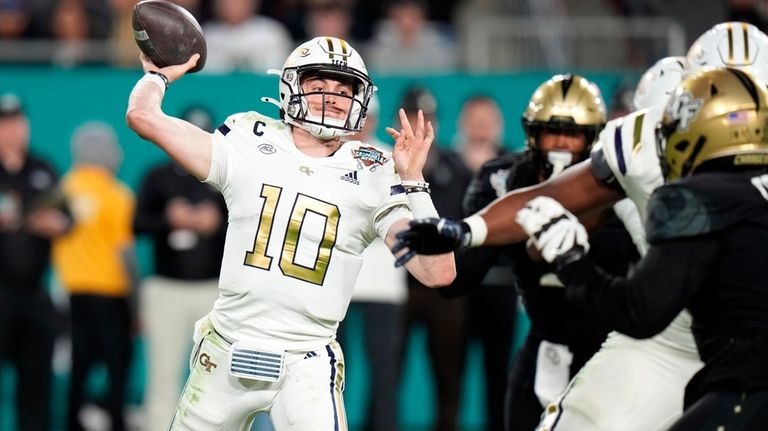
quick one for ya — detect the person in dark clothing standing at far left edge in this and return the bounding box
[0,94,71,431]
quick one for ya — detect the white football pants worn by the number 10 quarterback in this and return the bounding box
[170,319,347,431]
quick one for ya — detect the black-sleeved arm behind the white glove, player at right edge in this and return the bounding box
[557,236,719,338]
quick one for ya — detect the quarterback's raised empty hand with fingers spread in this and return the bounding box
[386,108,435,181]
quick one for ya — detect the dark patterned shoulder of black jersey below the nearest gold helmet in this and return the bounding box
[645,185,713,244]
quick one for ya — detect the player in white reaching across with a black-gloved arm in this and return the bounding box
[395,22,768,431]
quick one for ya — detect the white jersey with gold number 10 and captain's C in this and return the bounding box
[206,112,412,351]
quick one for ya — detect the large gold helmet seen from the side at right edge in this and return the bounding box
[656,68,768,181]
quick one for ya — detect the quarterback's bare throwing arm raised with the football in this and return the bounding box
[126,54,212,180]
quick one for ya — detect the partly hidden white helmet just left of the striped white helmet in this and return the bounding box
[632,57,686,110]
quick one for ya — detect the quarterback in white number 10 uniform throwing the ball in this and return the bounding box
[127,37,455,431]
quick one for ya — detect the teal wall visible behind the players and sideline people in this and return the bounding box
[0,66,639,431]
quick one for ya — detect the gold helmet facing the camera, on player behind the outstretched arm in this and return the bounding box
[522,75,606,177]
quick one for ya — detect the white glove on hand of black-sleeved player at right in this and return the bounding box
[515,196,589,263]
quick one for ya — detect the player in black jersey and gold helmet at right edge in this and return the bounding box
[517,68,768,431]
